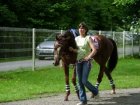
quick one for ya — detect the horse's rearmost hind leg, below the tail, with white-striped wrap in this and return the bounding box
[105,68,116,94]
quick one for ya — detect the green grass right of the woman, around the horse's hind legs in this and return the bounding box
[90,58,140,90]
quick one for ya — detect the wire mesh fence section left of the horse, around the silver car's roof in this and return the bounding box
[0,27,59,60]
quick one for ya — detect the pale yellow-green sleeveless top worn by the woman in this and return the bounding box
[75,35,91,60]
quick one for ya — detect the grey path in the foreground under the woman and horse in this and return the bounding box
[0,88,140,105]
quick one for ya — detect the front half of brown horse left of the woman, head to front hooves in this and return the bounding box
[53,30,79,101]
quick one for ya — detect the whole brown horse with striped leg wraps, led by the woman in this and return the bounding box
[54,30,118,101]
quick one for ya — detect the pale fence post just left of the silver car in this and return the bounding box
[32,28,35,71]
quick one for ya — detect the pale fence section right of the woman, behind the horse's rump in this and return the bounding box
[91,31,140,58]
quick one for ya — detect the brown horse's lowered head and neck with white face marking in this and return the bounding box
[54,30,75,66]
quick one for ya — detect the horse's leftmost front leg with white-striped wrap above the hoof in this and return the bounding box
[63,64,70,101]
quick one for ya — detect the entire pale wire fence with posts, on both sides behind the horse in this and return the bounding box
[0,27,140,69]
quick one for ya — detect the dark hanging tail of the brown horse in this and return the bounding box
[107,38,118,73]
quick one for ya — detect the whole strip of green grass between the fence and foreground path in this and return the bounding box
[0,58,140,102]
